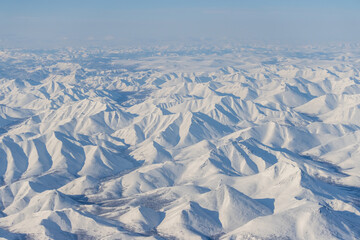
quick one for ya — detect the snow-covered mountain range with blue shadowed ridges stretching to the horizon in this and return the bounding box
[0,46,360,240]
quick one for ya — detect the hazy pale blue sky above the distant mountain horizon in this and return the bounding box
[0,0,360,48]
